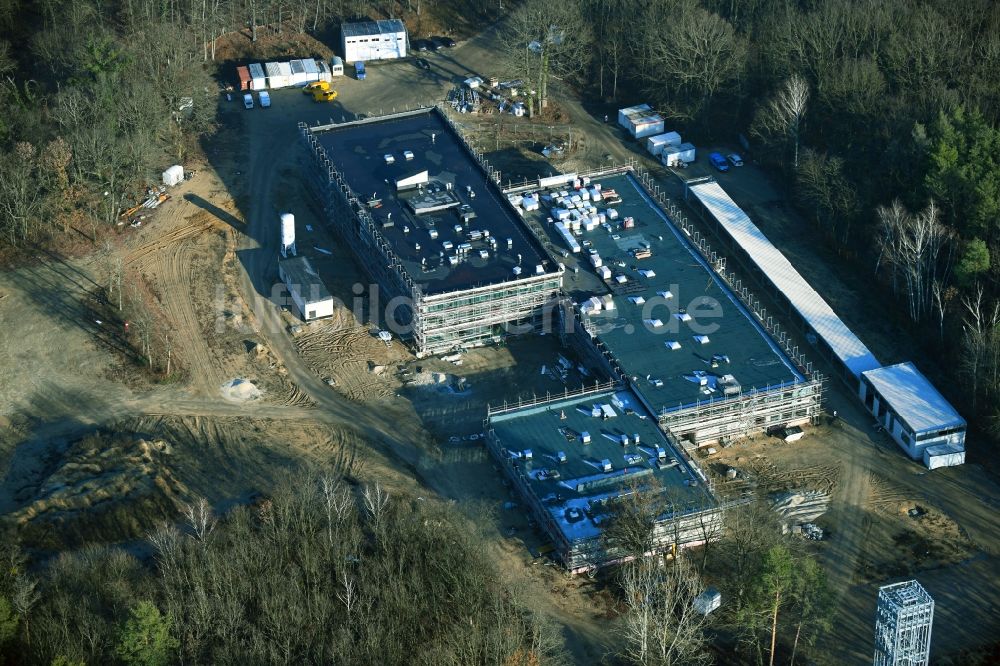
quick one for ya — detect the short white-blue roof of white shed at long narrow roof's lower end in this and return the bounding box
[864,363,965,434]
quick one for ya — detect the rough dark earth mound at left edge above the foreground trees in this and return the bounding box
[8,435,189,546]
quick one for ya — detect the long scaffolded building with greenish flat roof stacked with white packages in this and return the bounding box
[509,168,823,445]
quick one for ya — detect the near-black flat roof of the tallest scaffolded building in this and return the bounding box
[315,109,558,294]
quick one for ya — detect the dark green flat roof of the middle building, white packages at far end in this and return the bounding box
[533,175,804,410]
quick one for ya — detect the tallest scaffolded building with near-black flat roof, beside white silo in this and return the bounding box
[299,108,563,356]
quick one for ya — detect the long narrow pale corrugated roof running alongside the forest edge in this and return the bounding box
[689,182,879,377]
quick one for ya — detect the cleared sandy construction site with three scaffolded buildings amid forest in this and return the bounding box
[0,28,1000,664]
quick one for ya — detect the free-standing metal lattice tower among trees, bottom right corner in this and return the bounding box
[874,580,934,666]
